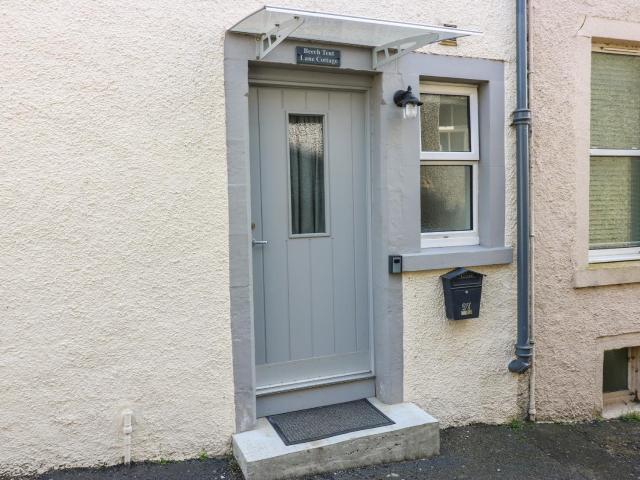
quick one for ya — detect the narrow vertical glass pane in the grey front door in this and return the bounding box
[289,114,326,235]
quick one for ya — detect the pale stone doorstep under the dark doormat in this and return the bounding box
[233,398,440,480]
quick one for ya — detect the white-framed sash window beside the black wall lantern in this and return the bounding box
[420,83,480,248]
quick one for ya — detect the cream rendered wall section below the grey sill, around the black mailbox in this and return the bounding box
[404,266,526,427]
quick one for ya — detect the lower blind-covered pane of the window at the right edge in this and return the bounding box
[589,157,640,249]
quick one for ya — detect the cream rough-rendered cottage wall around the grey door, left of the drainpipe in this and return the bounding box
[0,0,526,474]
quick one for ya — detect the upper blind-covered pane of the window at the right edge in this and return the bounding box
[591,53,640,150]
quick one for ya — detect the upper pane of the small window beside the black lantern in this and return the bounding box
[420,93,471,152]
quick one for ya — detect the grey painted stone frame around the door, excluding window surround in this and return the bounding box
[226,32,404,432]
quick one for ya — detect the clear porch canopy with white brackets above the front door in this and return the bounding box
[229,6,480,69]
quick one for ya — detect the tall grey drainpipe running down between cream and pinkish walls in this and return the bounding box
[509,0,532,373]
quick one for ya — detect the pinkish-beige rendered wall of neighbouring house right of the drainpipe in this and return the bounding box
[530,0,640,420]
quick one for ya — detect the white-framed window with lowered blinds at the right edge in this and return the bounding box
[589,45,640,263]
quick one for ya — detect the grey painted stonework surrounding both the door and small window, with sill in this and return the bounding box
[225,34,512,431]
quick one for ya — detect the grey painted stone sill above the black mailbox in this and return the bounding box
[402,245,513,272]
